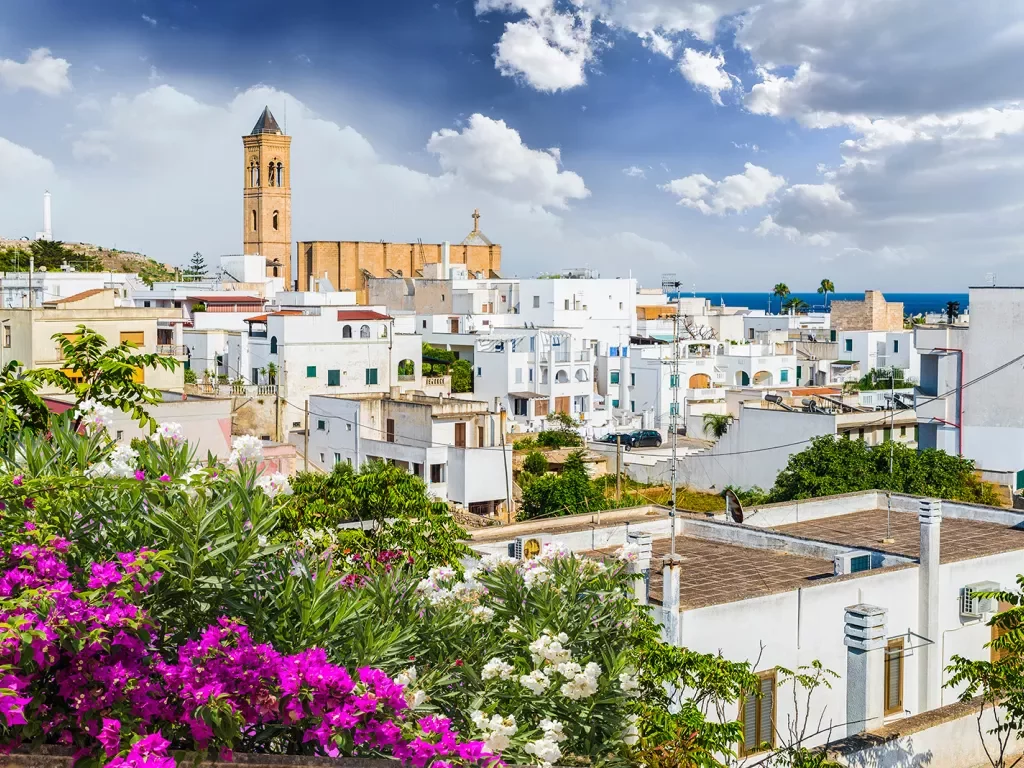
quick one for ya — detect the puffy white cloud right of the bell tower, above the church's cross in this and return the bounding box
[427,115,590,208]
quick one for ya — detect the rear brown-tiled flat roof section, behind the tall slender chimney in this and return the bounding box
[766,509,1024,562]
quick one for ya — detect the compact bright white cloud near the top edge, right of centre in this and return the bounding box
[495,10,594,92]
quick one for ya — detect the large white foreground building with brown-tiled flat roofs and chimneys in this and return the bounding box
[474,490,1024,766]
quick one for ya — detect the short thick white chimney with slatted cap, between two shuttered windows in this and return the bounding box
[843,604,886,736]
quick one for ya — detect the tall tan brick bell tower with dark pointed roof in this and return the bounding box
[242,106,292,291]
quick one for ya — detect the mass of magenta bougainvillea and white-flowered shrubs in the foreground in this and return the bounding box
[0,417,750,768]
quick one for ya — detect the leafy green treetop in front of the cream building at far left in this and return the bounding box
[35,326,179,428]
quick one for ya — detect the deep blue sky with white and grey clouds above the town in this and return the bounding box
[0,0,1024,291]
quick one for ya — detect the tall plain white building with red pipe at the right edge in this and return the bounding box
[914,287,1024,488]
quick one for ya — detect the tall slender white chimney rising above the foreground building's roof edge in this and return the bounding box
[918,499,942,712]
